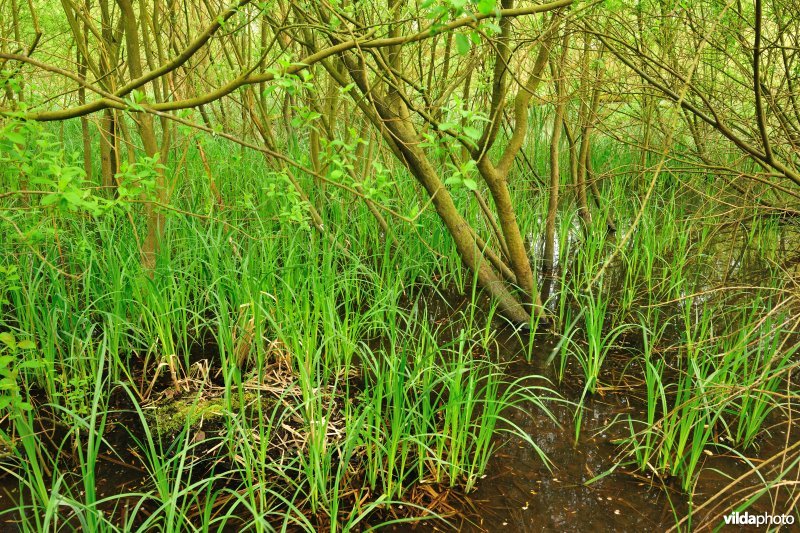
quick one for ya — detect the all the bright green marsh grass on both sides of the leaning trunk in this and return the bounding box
[0,118,797,531]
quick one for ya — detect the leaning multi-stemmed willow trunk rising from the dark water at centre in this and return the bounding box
[298,1,570,323]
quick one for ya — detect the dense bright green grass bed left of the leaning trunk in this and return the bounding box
[0,122,555,531]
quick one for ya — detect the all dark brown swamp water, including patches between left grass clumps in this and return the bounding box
[0,228,800,532]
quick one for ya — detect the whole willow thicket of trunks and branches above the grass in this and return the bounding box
[9,0,800,324]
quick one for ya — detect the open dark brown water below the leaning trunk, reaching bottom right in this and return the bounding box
[398,316,800,532]
